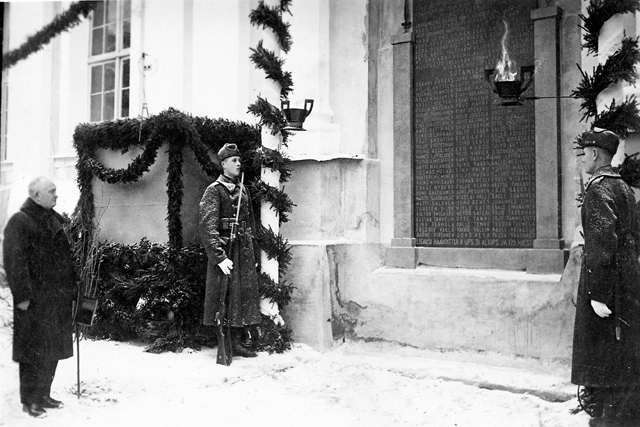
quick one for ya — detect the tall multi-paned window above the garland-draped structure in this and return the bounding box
[89,0,131,122]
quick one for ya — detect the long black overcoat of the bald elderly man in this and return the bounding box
[3,199,77,362]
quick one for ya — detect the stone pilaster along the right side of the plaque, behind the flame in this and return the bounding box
[527,6,564,273]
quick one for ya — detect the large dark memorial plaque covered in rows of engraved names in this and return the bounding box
[413,0,536,248]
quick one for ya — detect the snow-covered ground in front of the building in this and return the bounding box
[0,288,589,427]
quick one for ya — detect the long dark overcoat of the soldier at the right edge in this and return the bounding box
[571,166,640,387]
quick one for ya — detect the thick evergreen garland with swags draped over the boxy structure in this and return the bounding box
[73,108,293,248]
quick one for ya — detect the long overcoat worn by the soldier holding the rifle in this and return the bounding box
[200,175,261,327]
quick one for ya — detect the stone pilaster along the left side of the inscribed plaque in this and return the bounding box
[386,31,417,268]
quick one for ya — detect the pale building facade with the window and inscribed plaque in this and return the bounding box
[0,0,640,360]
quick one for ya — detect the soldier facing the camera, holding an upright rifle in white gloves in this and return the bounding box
[200,144,261,357]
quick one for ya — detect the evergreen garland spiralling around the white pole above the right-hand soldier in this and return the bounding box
[572,0,640,188]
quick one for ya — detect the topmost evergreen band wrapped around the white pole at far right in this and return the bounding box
[578,0,640,55]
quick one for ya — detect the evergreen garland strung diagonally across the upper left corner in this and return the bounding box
[2,1,98,71]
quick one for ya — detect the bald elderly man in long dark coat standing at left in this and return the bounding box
[3,178,77,417]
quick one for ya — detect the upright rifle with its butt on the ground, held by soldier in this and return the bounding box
[215,172,244,366]
